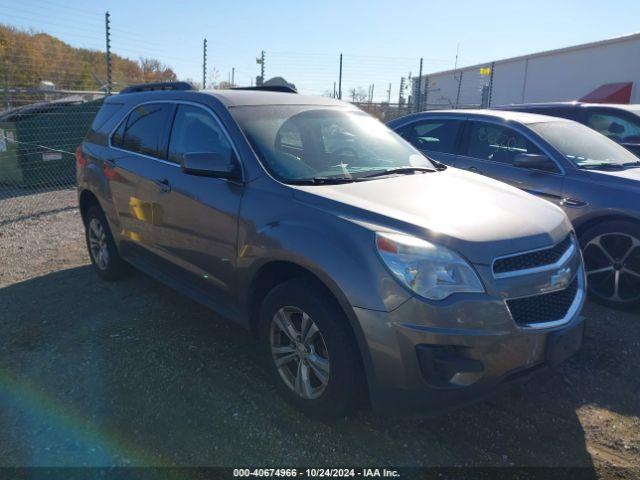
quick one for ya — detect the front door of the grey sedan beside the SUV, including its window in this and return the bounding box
[456,120,564,204]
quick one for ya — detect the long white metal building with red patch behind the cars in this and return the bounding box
[413,34,640,109]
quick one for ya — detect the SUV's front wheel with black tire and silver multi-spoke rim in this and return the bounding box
[259,278,363,420]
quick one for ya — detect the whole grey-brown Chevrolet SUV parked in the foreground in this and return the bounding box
[76,84,585,418]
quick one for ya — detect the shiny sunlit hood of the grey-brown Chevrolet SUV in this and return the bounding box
[293,167,571,265]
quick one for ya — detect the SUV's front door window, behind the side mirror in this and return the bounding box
[169,105,233,163]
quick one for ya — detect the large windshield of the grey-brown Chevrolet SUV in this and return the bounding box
[230,105,433,182]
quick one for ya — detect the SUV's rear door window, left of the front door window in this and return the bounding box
[111,103,171,158]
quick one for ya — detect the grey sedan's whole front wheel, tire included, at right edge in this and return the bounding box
[580,220,640,310]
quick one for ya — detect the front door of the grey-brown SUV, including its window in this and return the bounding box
[149,104,243,308]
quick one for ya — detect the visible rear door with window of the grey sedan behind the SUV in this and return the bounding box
[398,118,464,166]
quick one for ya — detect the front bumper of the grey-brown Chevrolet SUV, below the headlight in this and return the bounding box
[354,259,585,414]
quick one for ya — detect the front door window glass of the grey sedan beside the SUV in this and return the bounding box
[468,122,542,164]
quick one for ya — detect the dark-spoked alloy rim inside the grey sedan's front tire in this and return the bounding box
[584,232,640,303]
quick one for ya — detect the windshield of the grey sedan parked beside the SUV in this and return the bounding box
[529,122,638,168]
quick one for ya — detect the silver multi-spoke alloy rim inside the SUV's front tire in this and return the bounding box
[269,306,329,400]
